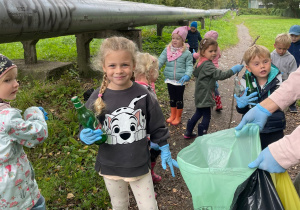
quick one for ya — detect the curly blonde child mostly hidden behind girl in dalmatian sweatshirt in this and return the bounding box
[134,53,161,183]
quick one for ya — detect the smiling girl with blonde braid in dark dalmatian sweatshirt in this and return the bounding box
[80,37,175,209]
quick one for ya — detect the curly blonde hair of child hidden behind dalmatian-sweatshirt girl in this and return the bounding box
[134,52,159,85]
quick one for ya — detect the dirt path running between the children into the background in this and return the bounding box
[130,24,300,210]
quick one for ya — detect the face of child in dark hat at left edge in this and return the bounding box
[0,68,19,100]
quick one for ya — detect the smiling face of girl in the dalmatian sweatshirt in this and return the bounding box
[102,50,135,90]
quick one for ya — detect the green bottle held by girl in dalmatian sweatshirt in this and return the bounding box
[71,96,107,145]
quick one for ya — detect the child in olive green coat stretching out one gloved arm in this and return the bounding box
[184,38,244,139]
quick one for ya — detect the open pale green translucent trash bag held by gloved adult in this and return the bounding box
[177,124,261,210]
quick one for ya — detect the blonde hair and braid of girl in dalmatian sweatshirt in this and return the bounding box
[92,36,138,115]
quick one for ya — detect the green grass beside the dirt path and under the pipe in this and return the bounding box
[0,14,296,209]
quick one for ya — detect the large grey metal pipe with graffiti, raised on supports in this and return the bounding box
[0,0,228,43]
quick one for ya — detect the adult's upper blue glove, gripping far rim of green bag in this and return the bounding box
[235,104,272,131]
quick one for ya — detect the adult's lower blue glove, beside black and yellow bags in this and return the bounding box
[248,147,286,173]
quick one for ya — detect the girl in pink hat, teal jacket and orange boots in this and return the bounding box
[158,26,193,125]
